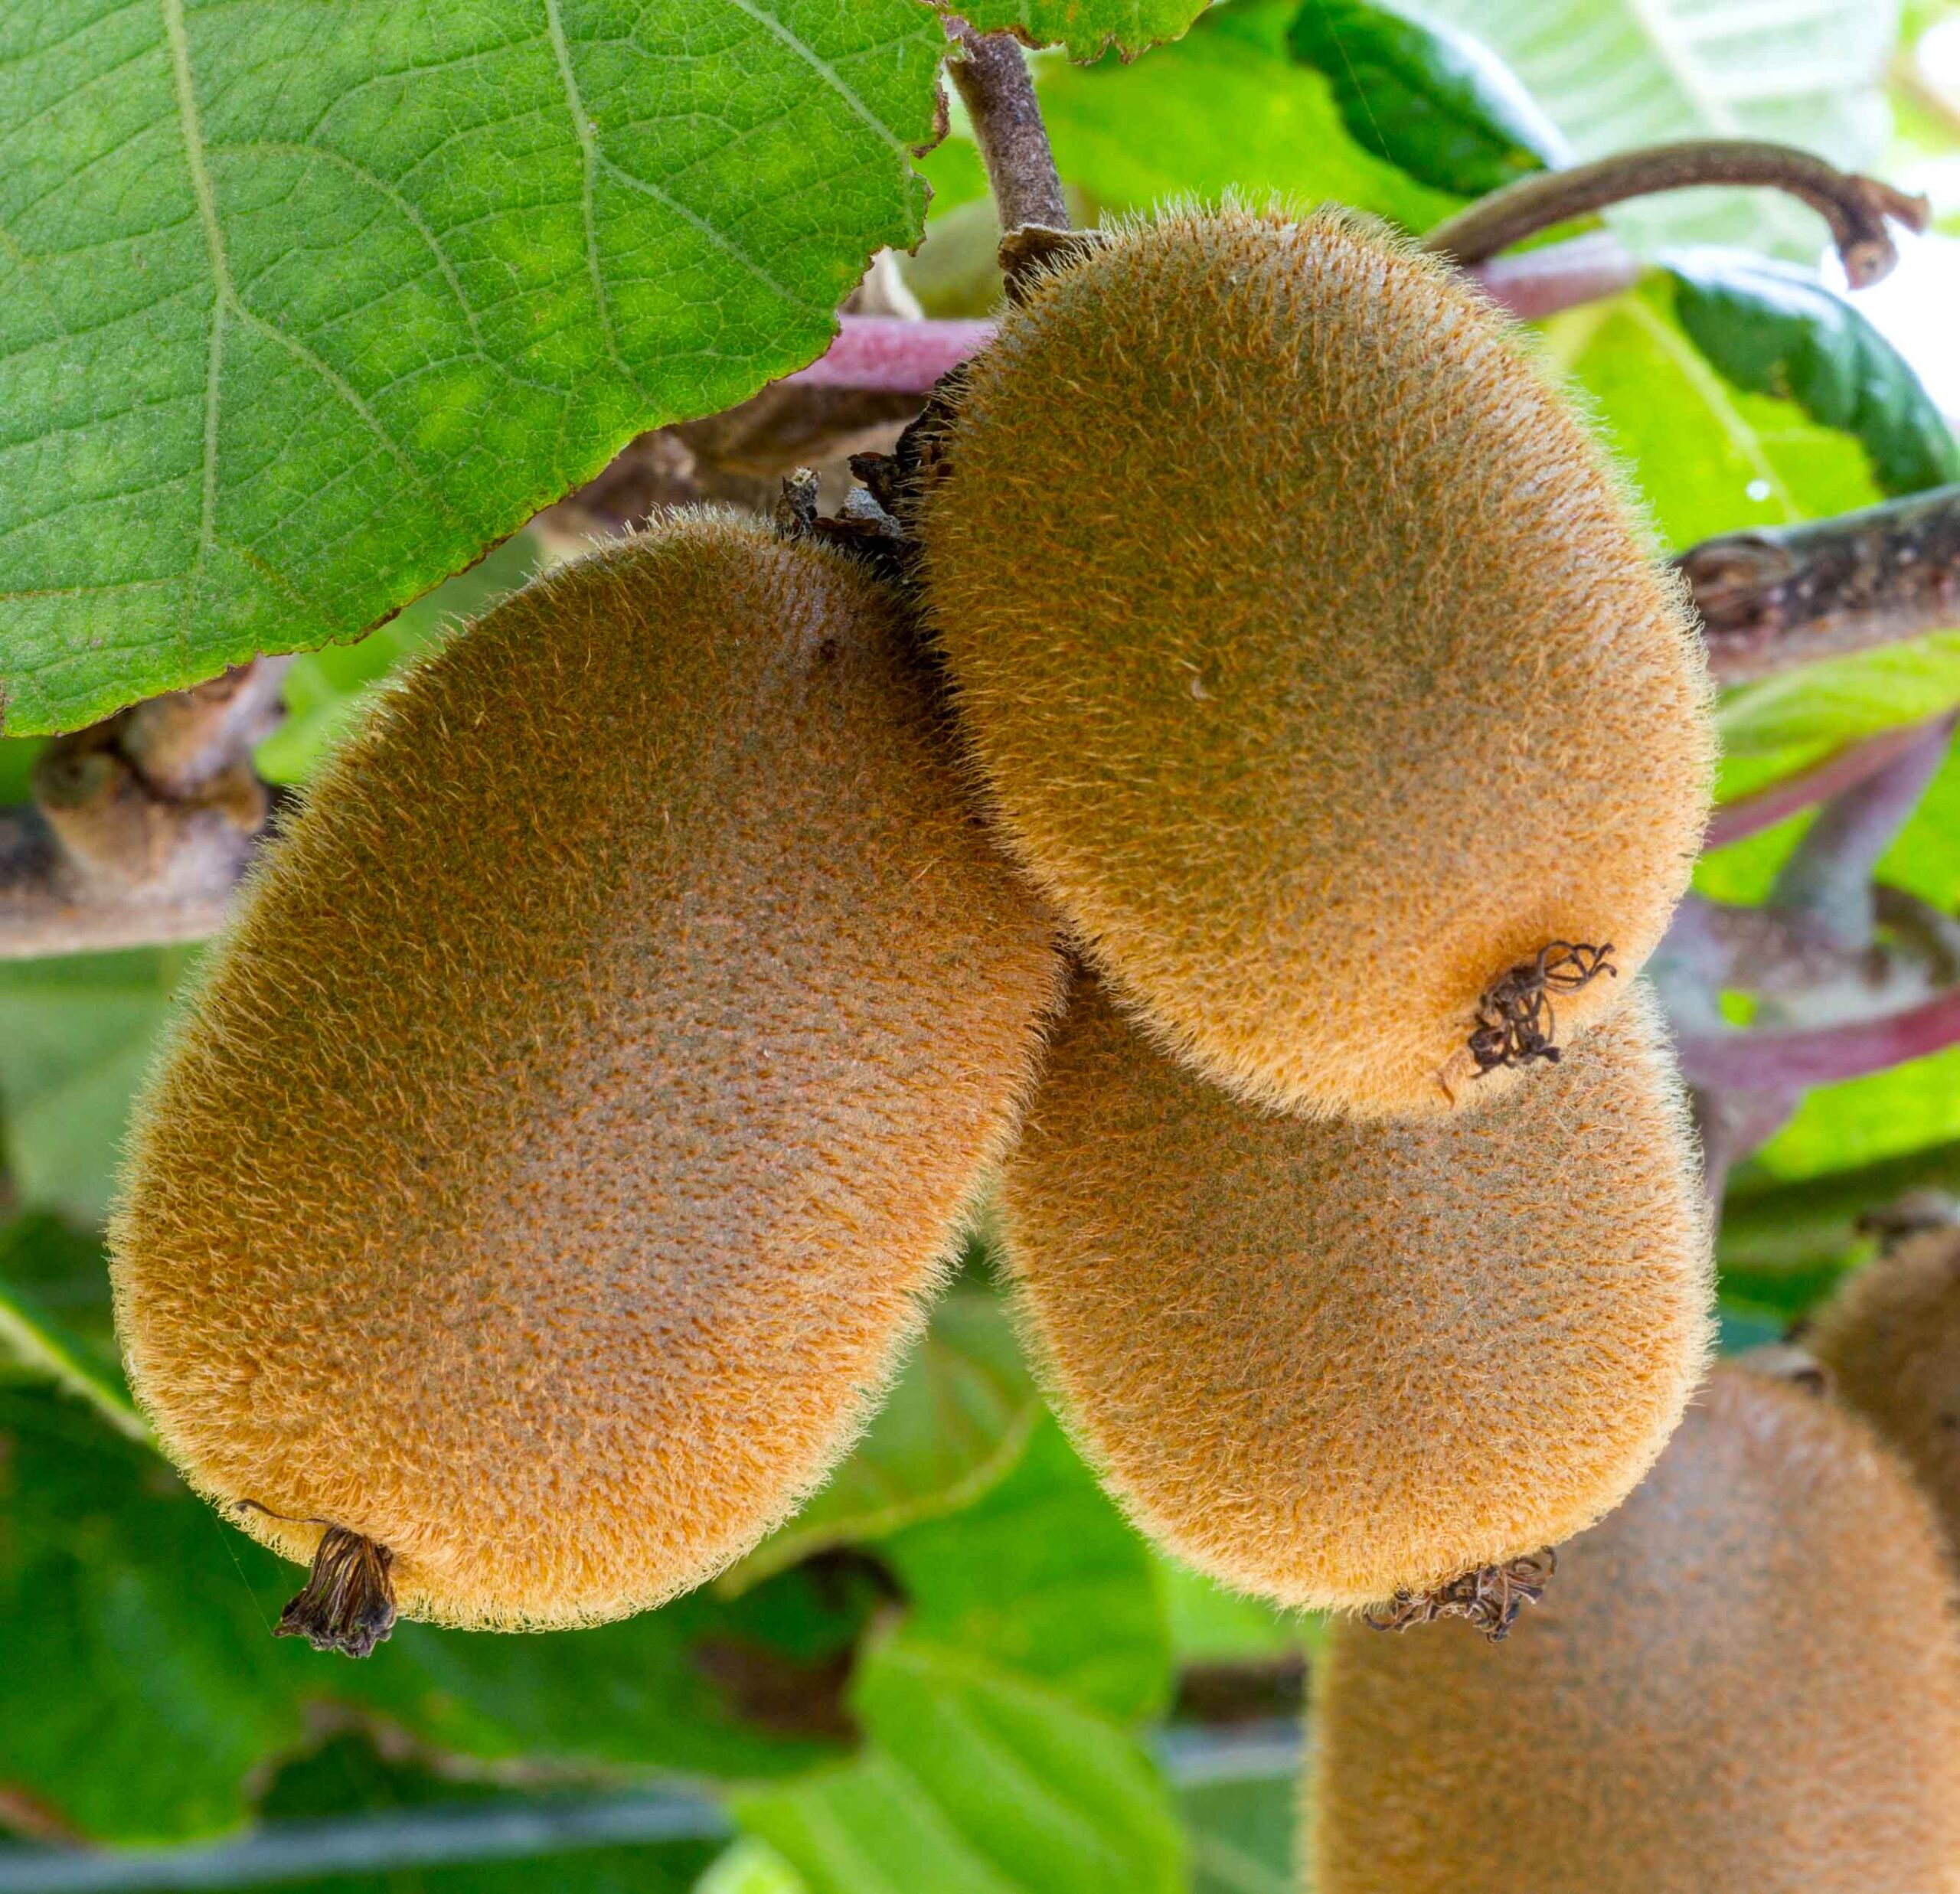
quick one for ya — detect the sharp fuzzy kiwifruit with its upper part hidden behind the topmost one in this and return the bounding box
[1004,986,1711,1631]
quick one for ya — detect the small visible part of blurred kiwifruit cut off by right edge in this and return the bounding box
[1799,1227,1960,1551]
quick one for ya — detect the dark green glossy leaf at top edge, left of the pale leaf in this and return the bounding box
[1288,0,1572,198]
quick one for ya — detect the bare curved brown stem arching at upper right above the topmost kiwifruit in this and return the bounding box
[1423,137,1931,290]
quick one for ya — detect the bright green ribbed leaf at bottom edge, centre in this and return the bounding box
[735,1635,1187,1894]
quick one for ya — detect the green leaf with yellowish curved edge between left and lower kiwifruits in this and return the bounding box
[724,1290,1043,1590]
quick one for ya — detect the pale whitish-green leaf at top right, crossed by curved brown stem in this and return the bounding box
[1423,0,1900,261]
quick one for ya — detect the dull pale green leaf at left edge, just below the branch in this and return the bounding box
[0,947,192,1223]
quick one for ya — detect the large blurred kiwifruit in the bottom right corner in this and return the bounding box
[1308,1367,1960,1894]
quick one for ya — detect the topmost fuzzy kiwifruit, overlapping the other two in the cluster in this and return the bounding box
[913,210,1713,1115]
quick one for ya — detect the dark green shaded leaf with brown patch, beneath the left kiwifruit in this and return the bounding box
[0,1378,878,1841]
